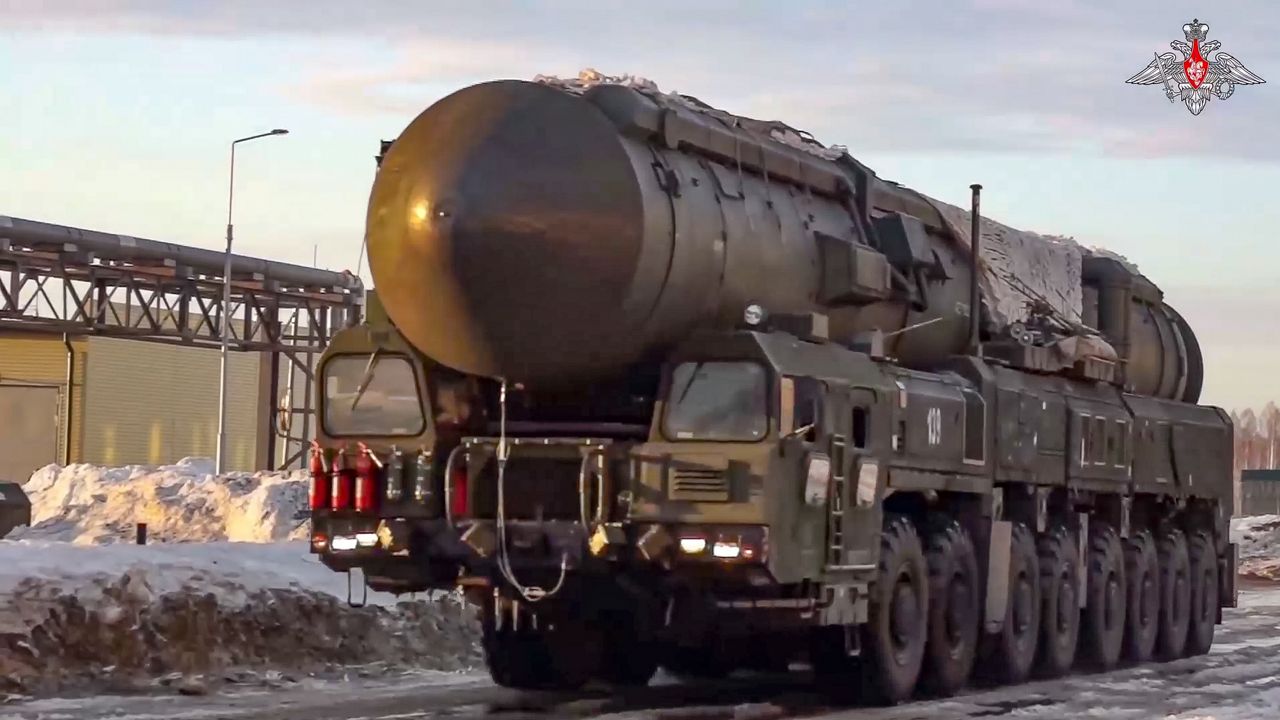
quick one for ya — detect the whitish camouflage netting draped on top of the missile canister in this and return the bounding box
[534,69,1135,335]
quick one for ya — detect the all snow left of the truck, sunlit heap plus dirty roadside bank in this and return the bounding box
[0,459,477,692]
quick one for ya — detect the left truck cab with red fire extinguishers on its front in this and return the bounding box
[308,291,467,592]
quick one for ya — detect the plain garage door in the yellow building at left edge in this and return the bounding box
[0,384,59,483]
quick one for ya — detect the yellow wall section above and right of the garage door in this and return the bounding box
[0,332,86,461]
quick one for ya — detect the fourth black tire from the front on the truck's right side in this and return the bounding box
[1036,525,1080,678]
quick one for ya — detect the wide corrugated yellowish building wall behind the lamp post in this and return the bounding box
[83,337,261,470]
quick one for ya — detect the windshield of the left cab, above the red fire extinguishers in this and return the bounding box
[324,352,425,437]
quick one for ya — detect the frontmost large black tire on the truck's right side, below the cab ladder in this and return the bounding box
[859,515,929,705]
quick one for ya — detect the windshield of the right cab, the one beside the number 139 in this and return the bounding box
[663,363,769,441]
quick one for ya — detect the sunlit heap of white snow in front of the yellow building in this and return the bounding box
[10,457,308,544]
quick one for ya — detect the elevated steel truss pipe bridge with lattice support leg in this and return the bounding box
[0,215,365,469]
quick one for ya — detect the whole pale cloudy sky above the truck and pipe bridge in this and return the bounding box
[0,0,1280,407]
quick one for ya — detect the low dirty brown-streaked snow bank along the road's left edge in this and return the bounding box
[0,541,479,693]
